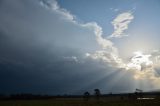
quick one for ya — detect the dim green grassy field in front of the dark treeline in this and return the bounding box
[0,98,160,106]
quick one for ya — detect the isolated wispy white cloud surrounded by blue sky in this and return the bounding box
[110,12,134,38]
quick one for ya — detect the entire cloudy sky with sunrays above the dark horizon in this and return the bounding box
[0,0,160,95]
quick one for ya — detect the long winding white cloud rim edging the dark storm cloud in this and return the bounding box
[40,0,125,67]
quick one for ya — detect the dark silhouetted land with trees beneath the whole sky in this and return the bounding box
[0,89,160,106]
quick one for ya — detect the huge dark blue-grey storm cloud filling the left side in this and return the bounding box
[0,0,135,94]
